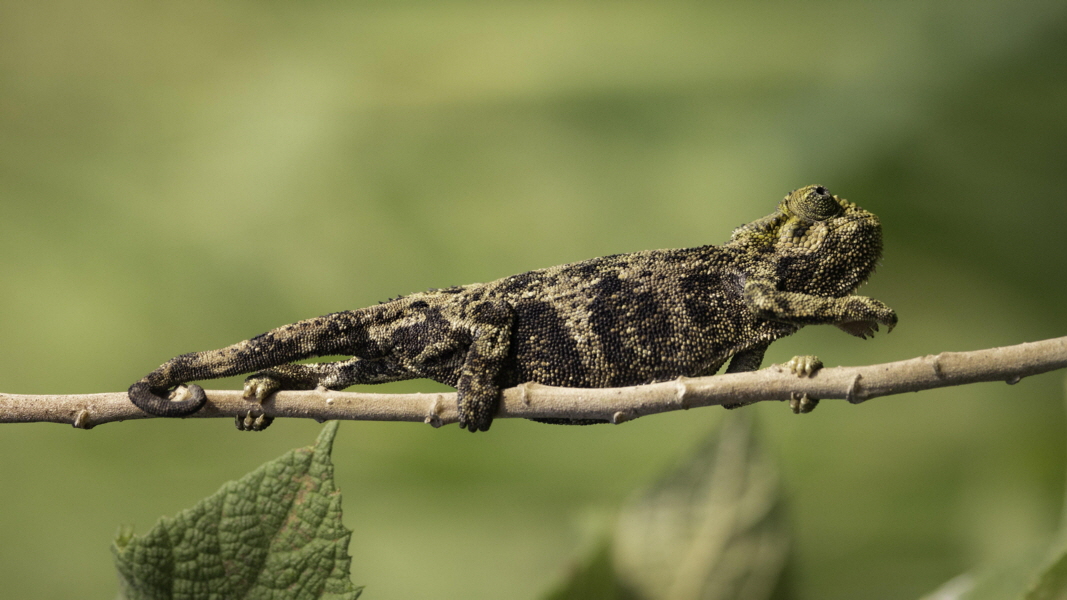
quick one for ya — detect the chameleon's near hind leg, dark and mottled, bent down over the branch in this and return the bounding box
[456,302,514,431]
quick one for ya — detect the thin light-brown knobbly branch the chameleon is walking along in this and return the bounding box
[0,337,1067,429]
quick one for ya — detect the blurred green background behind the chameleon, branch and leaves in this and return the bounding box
[0,0,1067,600]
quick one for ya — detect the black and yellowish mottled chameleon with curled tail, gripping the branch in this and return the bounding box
[129,186,896,431]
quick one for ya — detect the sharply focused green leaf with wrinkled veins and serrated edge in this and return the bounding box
[112,422,362,600]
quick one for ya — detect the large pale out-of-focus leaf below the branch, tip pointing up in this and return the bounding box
[614,413,789,600]
